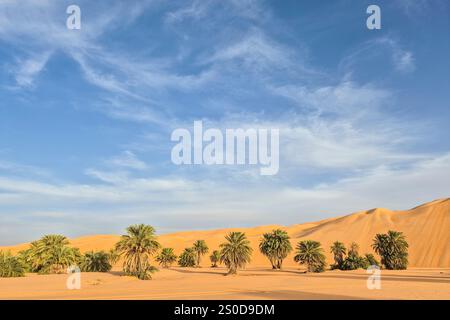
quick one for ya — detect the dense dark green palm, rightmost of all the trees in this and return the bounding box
[372,230,409,270]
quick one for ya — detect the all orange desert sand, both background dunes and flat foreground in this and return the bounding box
[0,199,450,299]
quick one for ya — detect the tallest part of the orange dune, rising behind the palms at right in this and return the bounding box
[289,199,450,267]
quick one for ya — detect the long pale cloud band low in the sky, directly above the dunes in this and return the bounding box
[0,154,450,242]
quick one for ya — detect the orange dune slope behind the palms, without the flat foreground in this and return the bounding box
[0,198,450,268]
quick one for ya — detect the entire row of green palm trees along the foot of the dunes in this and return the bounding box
[0,224,408,280]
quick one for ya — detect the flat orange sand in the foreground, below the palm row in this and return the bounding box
[0,267,450,299]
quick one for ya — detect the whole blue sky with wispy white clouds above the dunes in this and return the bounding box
[0,0,450,244]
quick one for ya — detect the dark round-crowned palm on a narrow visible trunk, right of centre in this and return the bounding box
[259,229,292,269]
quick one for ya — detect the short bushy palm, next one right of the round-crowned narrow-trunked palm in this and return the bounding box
[294,240,325,272]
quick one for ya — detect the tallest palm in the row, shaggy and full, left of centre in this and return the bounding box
[116,224,161,280]
